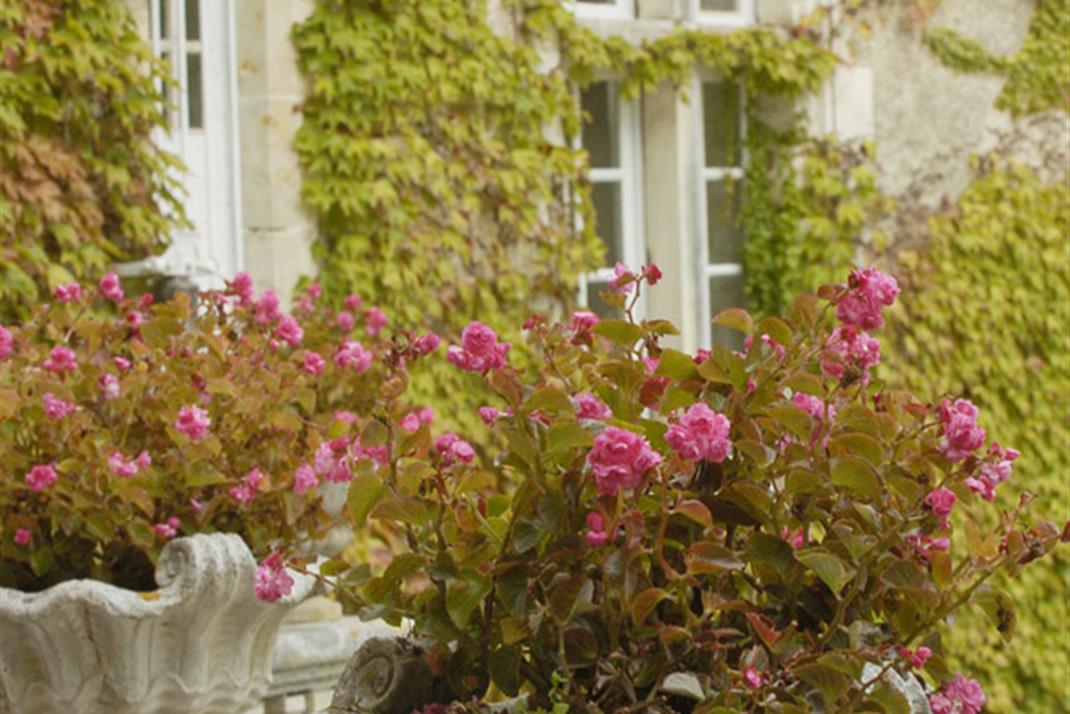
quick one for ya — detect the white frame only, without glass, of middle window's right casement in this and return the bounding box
[691,73,748,345]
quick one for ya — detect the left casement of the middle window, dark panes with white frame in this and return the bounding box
[579,81,645,315]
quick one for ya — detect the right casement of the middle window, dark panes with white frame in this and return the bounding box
[701,81,746,344]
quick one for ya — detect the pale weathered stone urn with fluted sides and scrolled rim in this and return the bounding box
[0,533,316,714]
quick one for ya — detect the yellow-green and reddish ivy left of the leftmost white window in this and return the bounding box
[0,0,179,321]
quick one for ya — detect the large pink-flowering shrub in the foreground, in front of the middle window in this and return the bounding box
[278,270,1060,712]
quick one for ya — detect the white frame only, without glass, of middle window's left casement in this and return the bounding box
[574,78,646,314]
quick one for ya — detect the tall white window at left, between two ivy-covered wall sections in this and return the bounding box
[144,0,243,287]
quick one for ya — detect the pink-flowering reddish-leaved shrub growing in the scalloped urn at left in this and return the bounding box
[0,274,437,593]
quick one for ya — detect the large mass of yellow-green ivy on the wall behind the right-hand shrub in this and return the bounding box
[883,166,1070,713]
